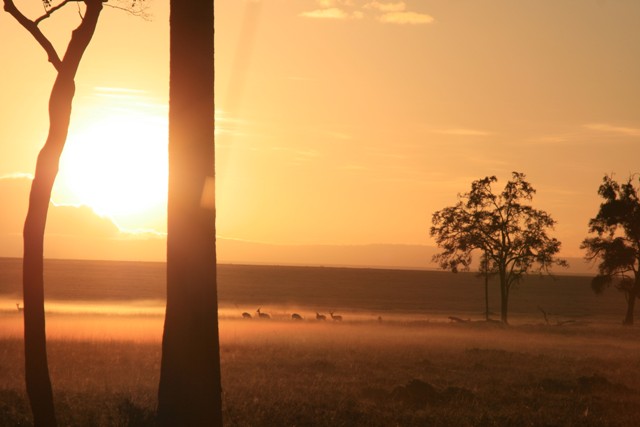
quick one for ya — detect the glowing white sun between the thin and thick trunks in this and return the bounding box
[54,109,168,230]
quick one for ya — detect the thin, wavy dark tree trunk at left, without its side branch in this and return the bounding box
[22,0,102,426]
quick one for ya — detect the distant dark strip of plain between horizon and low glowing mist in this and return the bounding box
[0,258,625,322]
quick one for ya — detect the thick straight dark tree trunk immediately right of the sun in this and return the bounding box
[158,0,222,426]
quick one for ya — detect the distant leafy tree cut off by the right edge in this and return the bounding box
[580,175,640,325]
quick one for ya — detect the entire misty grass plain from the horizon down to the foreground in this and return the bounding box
[0,259,640,426]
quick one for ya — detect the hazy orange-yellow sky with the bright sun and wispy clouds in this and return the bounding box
[0,0,640,265]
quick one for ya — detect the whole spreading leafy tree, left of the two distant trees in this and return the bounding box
[430,172,567,323]
